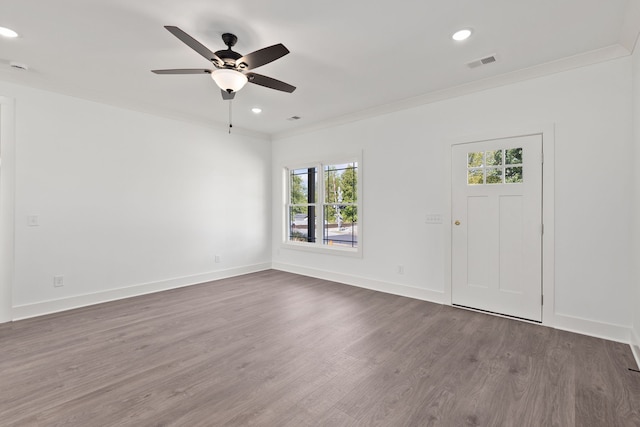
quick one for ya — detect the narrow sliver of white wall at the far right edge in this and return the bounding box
[631,43,640,365]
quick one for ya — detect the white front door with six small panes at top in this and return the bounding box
[451,135,542,322]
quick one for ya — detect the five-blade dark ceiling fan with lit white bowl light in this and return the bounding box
[151,25,296,100]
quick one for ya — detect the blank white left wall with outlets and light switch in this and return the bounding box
[0,83,271,318]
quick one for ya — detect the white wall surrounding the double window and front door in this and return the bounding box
[273,58,634,338]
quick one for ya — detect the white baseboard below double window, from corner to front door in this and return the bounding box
[272,262,444,304]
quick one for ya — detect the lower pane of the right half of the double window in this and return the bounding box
[322,204,358,248]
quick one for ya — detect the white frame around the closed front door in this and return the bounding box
[443,123,555,326]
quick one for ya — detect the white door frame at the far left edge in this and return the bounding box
[0,96,16,323]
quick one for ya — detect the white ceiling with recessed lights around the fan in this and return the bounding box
[0,0,637,135]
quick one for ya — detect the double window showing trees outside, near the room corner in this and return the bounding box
[286,161,359,252]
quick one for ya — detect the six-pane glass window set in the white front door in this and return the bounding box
[467,148,522,185]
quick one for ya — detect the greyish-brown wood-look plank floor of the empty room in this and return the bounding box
[0,271,640,427]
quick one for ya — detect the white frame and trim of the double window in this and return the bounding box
[281,154,363,257]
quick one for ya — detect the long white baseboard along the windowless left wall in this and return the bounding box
[12,263,271,320]
